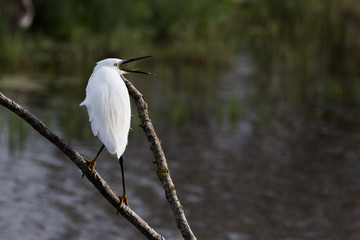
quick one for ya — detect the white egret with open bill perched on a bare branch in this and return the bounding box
[80,56,151,205]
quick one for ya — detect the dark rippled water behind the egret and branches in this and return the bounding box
[0,53,360,240]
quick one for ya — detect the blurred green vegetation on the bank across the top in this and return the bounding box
[0,0,360,73]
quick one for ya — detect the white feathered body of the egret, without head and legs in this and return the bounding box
[81,68,131,157]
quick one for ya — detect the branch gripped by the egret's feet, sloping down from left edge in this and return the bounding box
[0,92,165,240]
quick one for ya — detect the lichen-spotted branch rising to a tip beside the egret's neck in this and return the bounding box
[122,75,196,240]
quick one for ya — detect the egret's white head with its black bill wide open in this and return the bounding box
[94,56,152,75]
